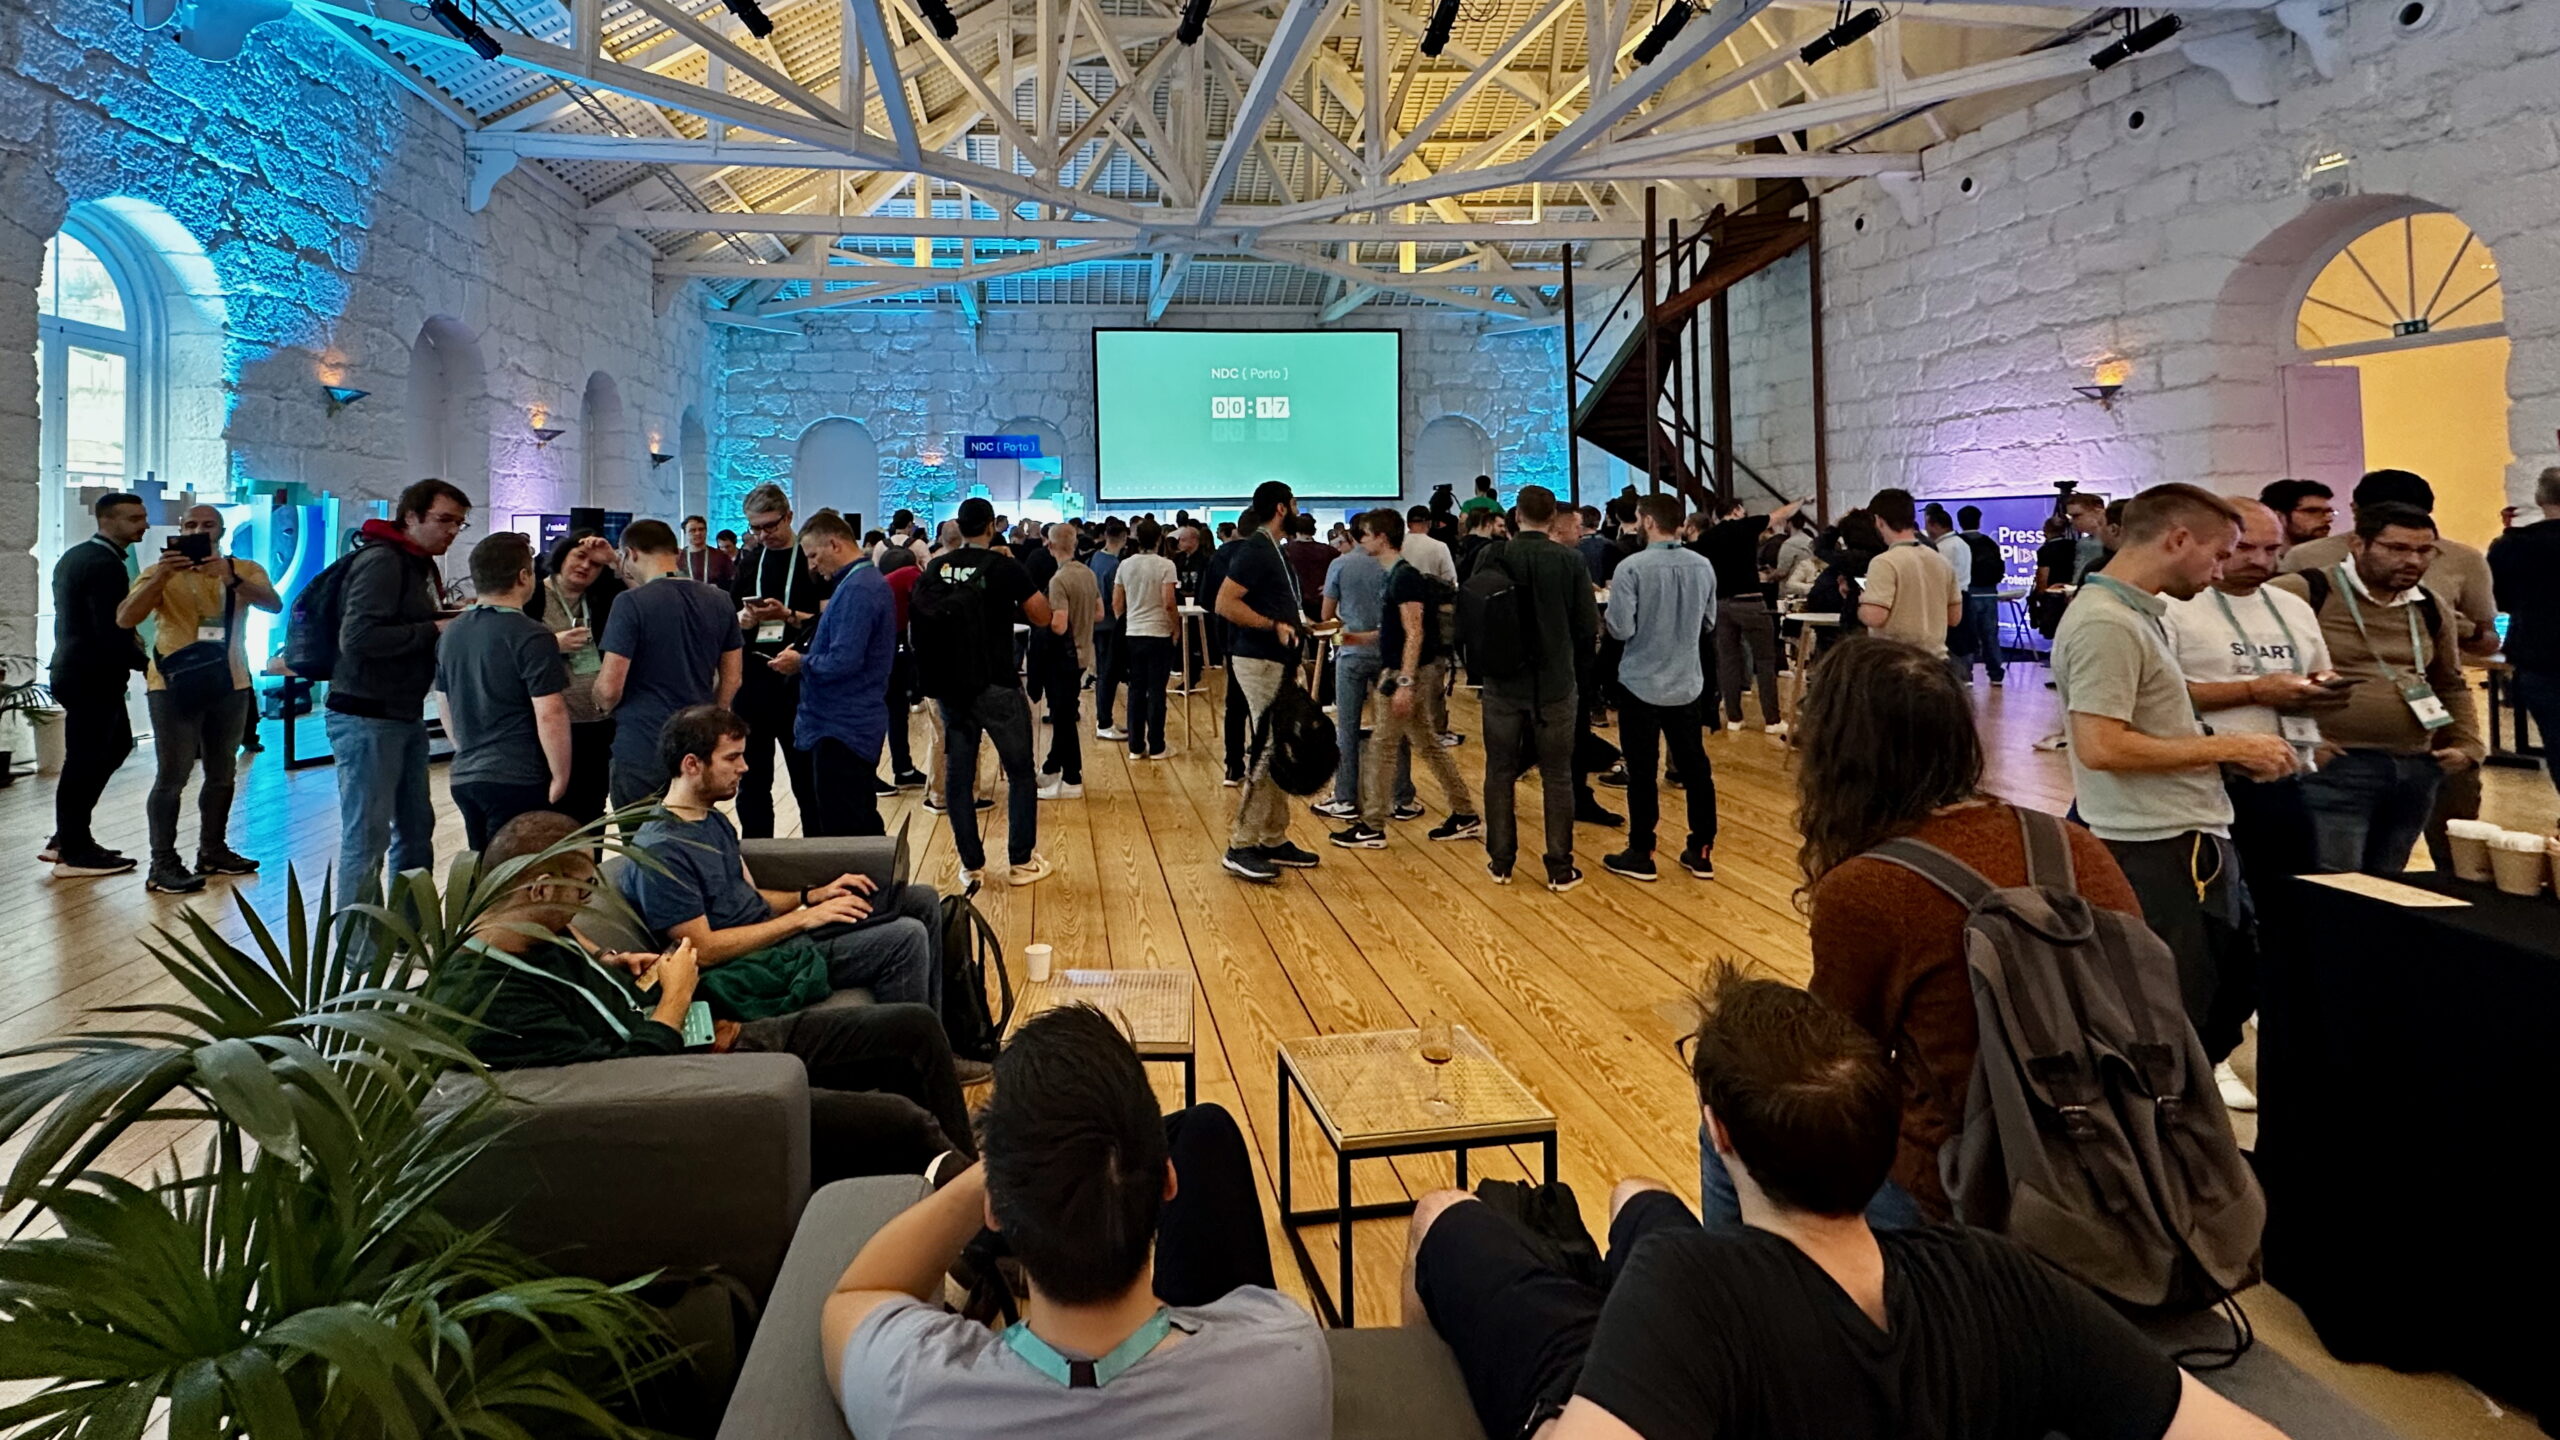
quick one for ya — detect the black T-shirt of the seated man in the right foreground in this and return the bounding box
[1580,1227,2181,1440]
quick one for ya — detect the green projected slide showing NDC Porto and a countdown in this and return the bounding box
[1093,331,1403,505]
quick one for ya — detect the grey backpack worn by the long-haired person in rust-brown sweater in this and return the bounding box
[1866,810,2266,1312]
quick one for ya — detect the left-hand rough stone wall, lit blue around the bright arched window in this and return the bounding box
[0,0,712,653]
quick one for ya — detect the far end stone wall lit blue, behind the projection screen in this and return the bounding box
[712,307,1564,523]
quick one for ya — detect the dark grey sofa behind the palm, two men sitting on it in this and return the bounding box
[438,838,896,1304]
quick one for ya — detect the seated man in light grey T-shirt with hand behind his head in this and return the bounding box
[819,1004,1334,1440]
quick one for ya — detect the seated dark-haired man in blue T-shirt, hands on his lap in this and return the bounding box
[625,705,947,1014]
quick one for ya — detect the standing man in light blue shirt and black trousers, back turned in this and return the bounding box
[1600,495,1715,881]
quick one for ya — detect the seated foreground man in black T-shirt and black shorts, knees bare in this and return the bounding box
[1405,966,2281,1440]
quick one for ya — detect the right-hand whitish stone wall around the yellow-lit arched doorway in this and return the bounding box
[1736,0,2560,510]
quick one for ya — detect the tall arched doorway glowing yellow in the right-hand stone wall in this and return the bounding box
[2286,210,2514,546]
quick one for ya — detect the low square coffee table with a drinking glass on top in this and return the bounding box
[1280,1025,1556,1327]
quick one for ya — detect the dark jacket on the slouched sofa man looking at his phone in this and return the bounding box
[440,940,684,1071]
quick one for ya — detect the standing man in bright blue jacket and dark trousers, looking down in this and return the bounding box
[776,510,906,835]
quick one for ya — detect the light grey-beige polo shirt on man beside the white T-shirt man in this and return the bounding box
[2053,577,2232,840]
